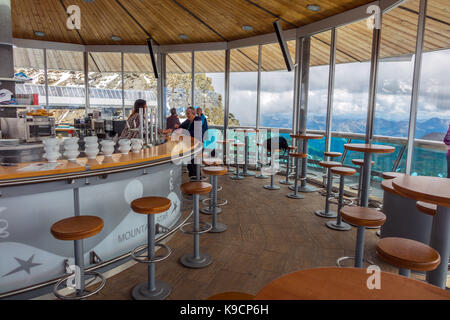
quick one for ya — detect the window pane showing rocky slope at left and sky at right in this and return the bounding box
[194,50,225,126]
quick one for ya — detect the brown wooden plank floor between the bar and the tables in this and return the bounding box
[91,171,428,300]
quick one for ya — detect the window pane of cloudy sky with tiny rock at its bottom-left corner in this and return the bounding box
[228,46,258,127]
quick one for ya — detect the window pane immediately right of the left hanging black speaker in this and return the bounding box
[166,52,192,122]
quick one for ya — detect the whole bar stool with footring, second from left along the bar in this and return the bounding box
[131,197,172,300]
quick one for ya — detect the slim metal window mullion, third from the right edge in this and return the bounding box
[325,28,337,156]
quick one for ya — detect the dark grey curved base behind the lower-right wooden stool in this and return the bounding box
[380,179,433,244]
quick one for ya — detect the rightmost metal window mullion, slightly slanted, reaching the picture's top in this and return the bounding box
[405,0,427,174]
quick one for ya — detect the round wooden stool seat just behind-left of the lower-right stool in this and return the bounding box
[341,206,386,227]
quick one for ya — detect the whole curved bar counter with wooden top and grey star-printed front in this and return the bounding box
[0,137,202,297]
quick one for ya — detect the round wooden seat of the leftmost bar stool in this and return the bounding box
[50,216,104,241]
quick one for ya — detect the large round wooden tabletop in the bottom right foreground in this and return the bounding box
[255,267,450,300]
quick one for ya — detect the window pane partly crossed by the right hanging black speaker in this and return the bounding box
[261,40,295,129]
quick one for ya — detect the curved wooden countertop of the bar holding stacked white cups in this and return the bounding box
[0,137,202,184]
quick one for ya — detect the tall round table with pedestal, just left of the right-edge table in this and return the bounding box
[344,143,395,207]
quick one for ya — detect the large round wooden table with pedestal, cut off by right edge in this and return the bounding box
[392,175,450,288]
